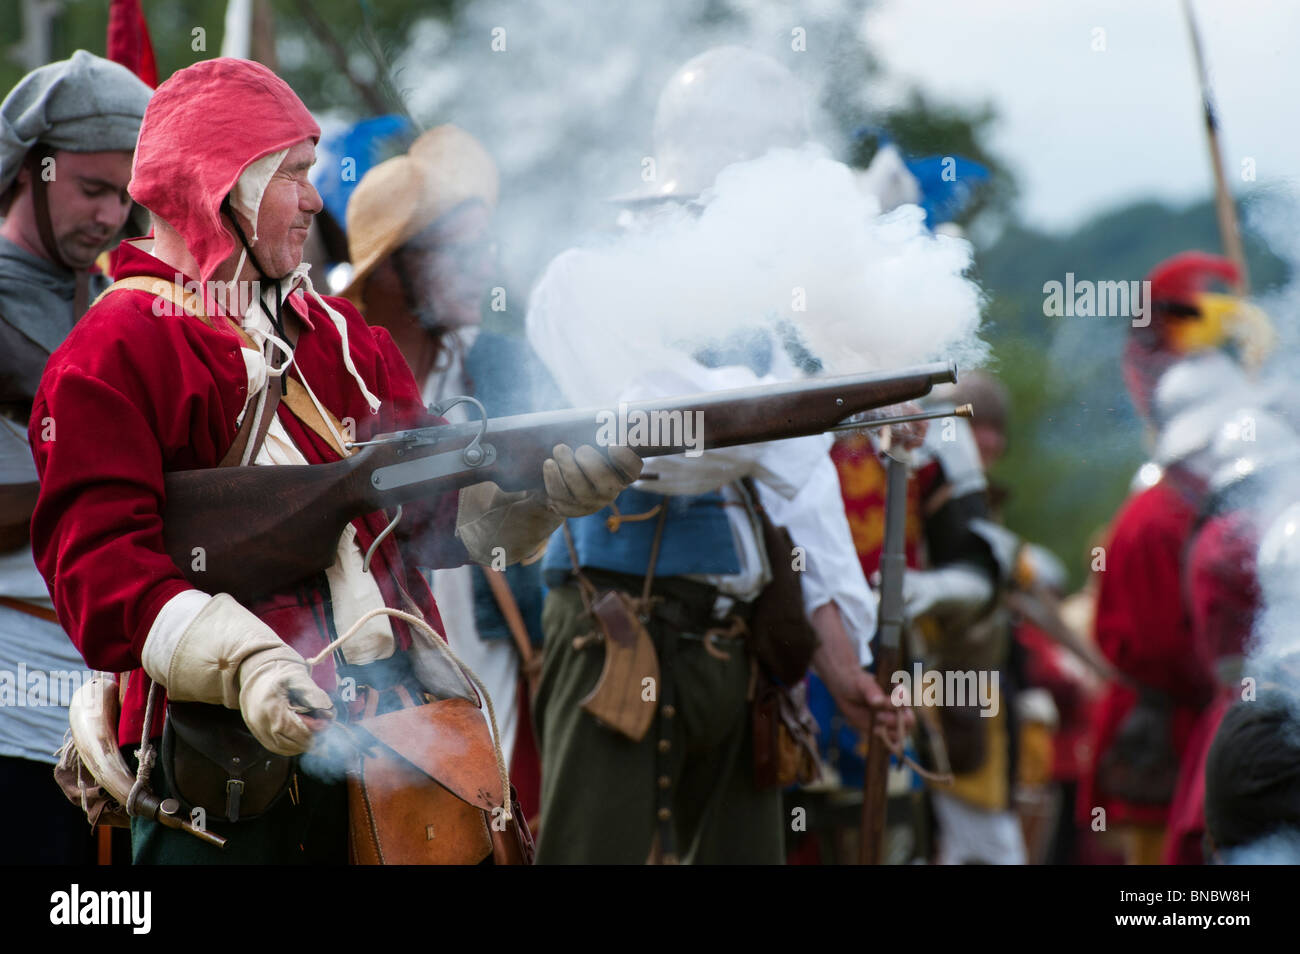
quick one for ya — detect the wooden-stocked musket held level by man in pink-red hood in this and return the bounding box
[163,361,957,600]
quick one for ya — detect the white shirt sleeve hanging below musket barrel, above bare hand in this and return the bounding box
[758,454,876,665]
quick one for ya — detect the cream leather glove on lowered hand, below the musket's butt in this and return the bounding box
[142,593,334,755]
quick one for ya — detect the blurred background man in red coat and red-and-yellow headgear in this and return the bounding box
[1078,252,1270,864]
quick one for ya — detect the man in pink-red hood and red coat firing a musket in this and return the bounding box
[31,58,640,862]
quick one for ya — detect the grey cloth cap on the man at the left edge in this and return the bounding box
[0,49,153,195]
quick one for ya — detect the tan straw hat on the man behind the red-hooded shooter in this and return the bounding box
[343,125,499,303]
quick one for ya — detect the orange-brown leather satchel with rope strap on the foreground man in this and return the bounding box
[347,691,533,864]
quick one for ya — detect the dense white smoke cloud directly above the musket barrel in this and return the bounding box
[529,148,985,404]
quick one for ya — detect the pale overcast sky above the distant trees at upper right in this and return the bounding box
[863,0,1300,229]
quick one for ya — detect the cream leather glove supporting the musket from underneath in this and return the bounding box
[456,445,641,565]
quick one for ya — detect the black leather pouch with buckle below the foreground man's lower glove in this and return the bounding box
[163,702,295,821]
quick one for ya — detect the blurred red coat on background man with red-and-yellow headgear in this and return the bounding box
[1078,476,1212,825]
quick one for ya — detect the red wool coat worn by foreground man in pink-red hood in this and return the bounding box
[31,244,468,745]
